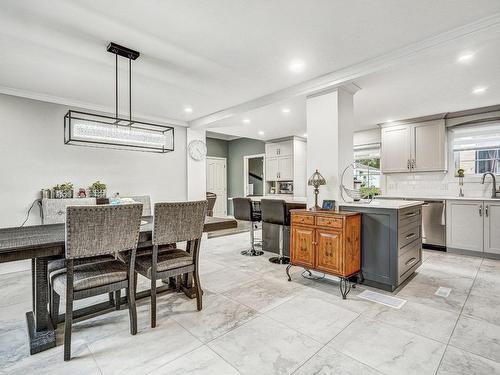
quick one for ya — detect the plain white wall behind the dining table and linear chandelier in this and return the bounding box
[0,95,187,227]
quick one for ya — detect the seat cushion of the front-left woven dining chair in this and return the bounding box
[53,260,127,295]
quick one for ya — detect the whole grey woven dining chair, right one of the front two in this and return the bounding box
[136,201,207,328]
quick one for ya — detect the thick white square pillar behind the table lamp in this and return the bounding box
[307,87,355,207]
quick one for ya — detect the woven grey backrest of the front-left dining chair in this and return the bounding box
[66,203,142,259]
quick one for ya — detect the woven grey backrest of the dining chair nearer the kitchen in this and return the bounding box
[153,201,207,245]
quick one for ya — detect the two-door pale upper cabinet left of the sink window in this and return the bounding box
[380,120,447,173]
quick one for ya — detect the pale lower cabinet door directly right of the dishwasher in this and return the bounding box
[446,201,484,252]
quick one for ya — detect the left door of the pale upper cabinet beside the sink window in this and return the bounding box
[380,125,411,173]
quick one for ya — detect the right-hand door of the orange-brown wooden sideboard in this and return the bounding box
[316,229,343,275]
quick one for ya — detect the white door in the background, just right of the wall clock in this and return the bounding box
[206,157,227,217]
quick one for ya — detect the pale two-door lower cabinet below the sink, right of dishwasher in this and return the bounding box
[446,200,500,254]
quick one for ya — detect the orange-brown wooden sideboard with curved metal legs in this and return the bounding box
[287,210,361,299]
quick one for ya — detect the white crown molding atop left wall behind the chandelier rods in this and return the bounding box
[0,86,188,127]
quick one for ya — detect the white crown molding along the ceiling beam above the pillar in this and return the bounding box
[188,13,500,128]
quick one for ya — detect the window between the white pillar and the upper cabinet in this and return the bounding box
[354,146,381,197]
